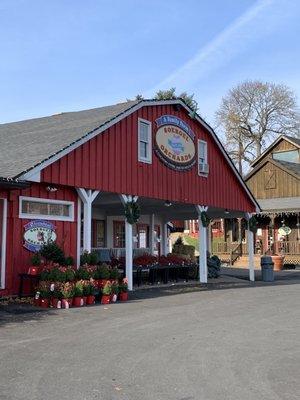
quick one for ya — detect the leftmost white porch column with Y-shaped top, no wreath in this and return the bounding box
[77,188,99,253]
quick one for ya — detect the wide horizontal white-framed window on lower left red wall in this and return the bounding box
[19,196,74,221]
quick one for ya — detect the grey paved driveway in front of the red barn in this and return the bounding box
[0,280,300,400]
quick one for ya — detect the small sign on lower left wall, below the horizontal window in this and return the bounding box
[24,220,56,253]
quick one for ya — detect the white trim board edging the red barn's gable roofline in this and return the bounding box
[18,99,260,213]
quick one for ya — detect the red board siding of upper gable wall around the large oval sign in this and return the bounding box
[42,105,255,212]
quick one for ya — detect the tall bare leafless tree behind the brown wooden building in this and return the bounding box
[216,81,299,173]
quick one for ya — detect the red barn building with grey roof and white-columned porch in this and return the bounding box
[0,100,259,295]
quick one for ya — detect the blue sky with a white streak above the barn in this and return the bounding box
[0,0,300,124]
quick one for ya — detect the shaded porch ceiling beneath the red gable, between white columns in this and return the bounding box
[93,192,245,221]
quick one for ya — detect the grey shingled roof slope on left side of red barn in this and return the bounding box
[0,101,139,178]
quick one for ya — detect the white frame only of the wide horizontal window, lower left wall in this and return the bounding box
[19,196,74,222]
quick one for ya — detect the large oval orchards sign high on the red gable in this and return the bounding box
[155,115,196,171]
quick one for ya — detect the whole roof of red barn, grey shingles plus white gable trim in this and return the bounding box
[0,98,260,212]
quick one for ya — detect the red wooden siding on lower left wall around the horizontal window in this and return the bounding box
[0,184,77,295]
